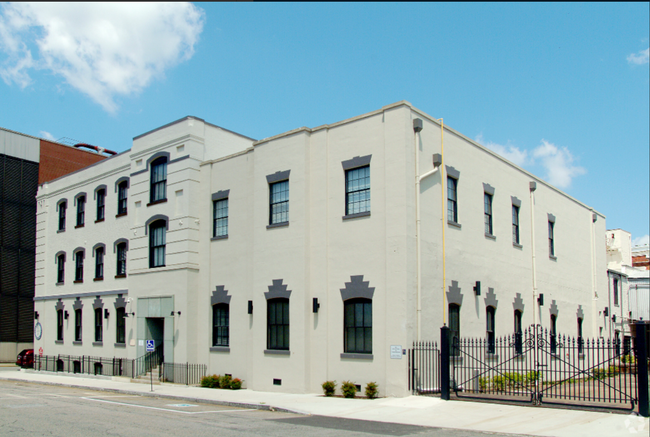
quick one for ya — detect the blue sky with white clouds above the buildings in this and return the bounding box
[0,3,650,244]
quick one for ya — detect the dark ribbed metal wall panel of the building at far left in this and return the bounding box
[0,154,38,342]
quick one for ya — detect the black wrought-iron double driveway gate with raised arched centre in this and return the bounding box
[450,325,637,409]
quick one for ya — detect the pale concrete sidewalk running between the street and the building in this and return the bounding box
[0,368,650,437]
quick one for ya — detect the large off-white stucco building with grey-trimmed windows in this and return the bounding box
[35,102,607,396]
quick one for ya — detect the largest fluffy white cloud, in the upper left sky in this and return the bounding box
[0,3,204,112]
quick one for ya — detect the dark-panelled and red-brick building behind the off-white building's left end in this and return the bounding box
[0,128,104,361]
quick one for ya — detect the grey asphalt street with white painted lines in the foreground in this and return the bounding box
[0,381,528,437]
